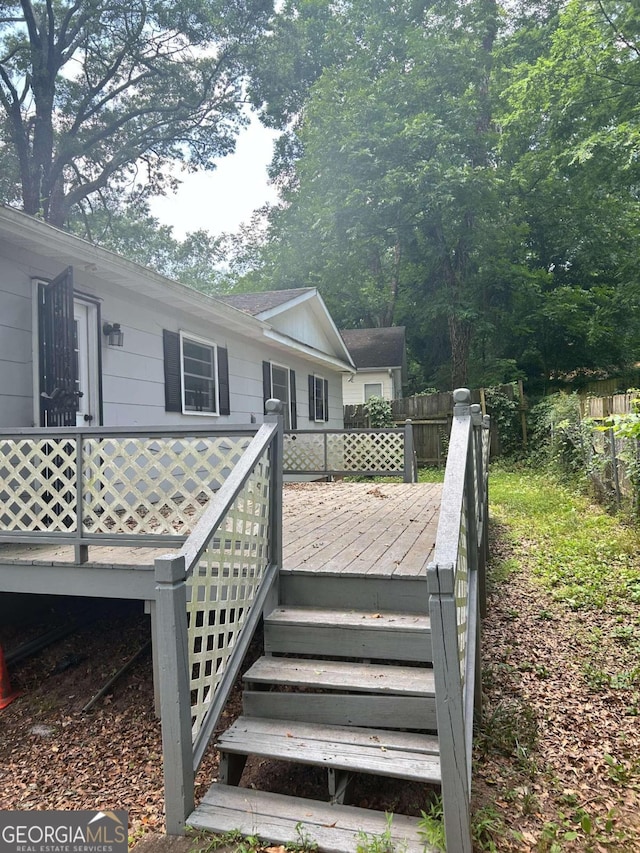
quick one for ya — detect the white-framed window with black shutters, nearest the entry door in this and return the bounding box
[163,329,230,415]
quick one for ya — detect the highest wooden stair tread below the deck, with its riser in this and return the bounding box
[264,607,431,664]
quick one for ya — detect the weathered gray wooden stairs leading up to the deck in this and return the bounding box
[188,572,441,853]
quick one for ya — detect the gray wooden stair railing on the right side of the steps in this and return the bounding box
[427,388,489,853]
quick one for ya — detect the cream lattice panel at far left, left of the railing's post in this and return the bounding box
[0,438,77,533]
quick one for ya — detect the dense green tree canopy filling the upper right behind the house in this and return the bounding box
[238,0,640,386]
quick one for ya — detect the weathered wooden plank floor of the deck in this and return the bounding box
[0,482,442,584]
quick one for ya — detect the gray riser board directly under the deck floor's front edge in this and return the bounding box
[278,568,429,614]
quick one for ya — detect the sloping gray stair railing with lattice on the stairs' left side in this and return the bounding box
[154,400,282,835]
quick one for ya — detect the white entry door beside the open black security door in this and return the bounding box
[73,299,100,426]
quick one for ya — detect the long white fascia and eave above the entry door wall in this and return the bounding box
[0,205,265,337]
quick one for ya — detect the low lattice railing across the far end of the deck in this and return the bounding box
[284,421,417,483]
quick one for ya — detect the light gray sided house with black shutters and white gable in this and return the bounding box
[0,206,354,429]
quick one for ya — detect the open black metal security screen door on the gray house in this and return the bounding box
[38,267,79,427]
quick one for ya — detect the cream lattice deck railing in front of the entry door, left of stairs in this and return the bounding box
[0,427,257,545]
